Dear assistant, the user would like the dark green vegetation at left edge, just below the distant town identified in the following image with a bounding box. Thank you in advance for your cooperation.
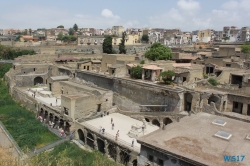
[0,45,36,60]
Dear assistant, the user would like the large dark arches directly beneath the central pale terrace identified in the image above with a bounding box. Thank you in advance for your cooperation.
[77,129,137,166]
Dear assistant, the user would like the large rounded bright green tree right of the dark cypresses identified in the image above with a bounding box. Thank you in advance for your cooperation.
[145,43,172,61]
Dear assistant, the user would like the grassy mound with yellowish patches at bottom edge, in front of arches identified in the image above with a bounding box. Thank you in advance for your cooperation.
[31,142,117,166]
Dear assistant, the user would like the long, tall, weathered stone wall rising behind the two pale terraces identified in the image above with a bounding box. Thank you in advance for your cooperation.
[76,71,183,112]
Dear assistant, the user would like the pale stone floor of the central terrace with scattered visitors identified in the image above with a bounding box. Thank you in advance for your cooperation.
[82,113,159,148]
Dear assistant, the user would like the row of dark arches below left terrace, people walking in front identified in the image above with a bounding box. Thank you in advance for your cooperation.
[39,108,70,133]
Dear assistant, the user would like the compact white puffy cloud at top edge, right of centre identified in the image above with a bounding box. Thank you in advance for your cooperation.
[177,0,201,11]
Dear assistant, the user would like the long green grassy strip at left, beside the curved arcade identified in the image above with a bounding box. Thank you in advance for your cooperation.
[0,81,58,151]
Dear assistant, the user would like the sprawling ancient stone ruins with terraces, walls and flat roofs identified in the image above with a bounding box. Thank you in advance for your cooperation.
[4,41,250,166]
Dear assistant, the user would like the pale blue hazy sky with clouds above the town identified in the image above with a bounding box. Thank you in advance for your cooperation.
[0,0,250,31]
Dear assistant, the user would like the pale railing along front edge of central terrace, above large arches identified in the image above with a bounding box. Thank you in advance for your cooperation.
[81,122,140,153]
